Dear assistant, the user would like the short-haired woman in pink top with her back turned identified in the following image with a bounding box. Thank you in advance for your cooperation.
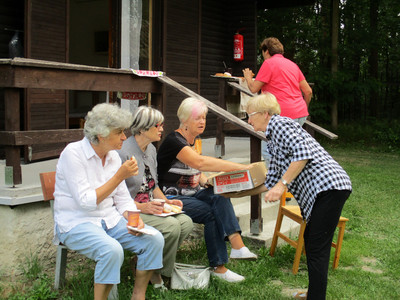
[243,37,312,166]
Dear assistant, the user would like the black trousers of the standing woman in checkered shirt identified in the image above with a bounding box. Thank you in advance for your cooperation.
[304,190,350,300]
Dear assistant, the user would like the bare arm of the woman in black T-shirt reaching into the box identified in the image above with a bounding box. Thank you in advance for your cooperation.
[176,146,250,172]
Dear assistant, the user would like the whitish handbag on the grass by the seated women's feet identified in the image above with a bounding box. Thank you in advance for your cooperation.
[171,263,210,290]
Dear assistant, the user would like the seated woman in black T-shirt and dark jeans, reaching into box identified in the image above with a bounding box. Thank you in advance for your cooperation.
[157,98,257,282]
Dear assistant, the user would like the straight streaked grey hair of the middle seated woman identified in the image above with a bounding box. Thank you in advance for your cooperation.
[131,105,164,135]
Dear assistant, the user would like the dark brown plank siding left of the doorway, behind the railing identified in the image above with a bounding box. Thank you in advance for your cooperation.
[24,0,69,162]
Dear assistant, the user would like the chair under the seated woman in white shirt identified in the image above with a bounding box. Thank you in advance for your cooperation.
[39,172,118,300]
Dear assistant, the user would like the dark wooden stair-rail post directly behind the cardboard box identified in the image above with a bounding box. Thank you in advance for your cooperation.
[250,135,263,234]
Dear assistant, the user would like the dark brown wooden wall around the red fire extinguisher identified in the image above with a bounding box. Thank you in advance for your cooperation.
[159,0,256,137]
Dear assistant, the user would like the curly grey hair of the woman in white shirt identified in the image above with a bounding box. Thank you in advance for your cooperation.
[83,103,132,145]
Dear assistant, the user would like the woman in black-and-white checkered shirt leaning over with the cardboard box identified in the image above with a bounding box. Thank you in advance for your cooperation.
[246,93,352,300]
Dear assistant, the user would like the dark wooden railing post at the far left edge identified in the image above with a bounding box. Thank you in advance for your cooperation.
[4,88,22,185]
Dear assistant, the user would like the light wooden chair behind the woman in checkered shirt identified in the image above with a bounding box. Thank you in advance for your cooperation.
[269,192,349,274]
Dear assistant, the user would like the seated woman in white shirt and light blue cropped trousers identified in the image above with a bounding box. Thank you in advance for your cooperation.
[54,103,164,299]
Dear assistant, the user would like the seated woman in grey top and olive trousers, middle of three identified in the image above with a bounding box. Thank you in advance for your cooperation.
[118,105,193,289]
